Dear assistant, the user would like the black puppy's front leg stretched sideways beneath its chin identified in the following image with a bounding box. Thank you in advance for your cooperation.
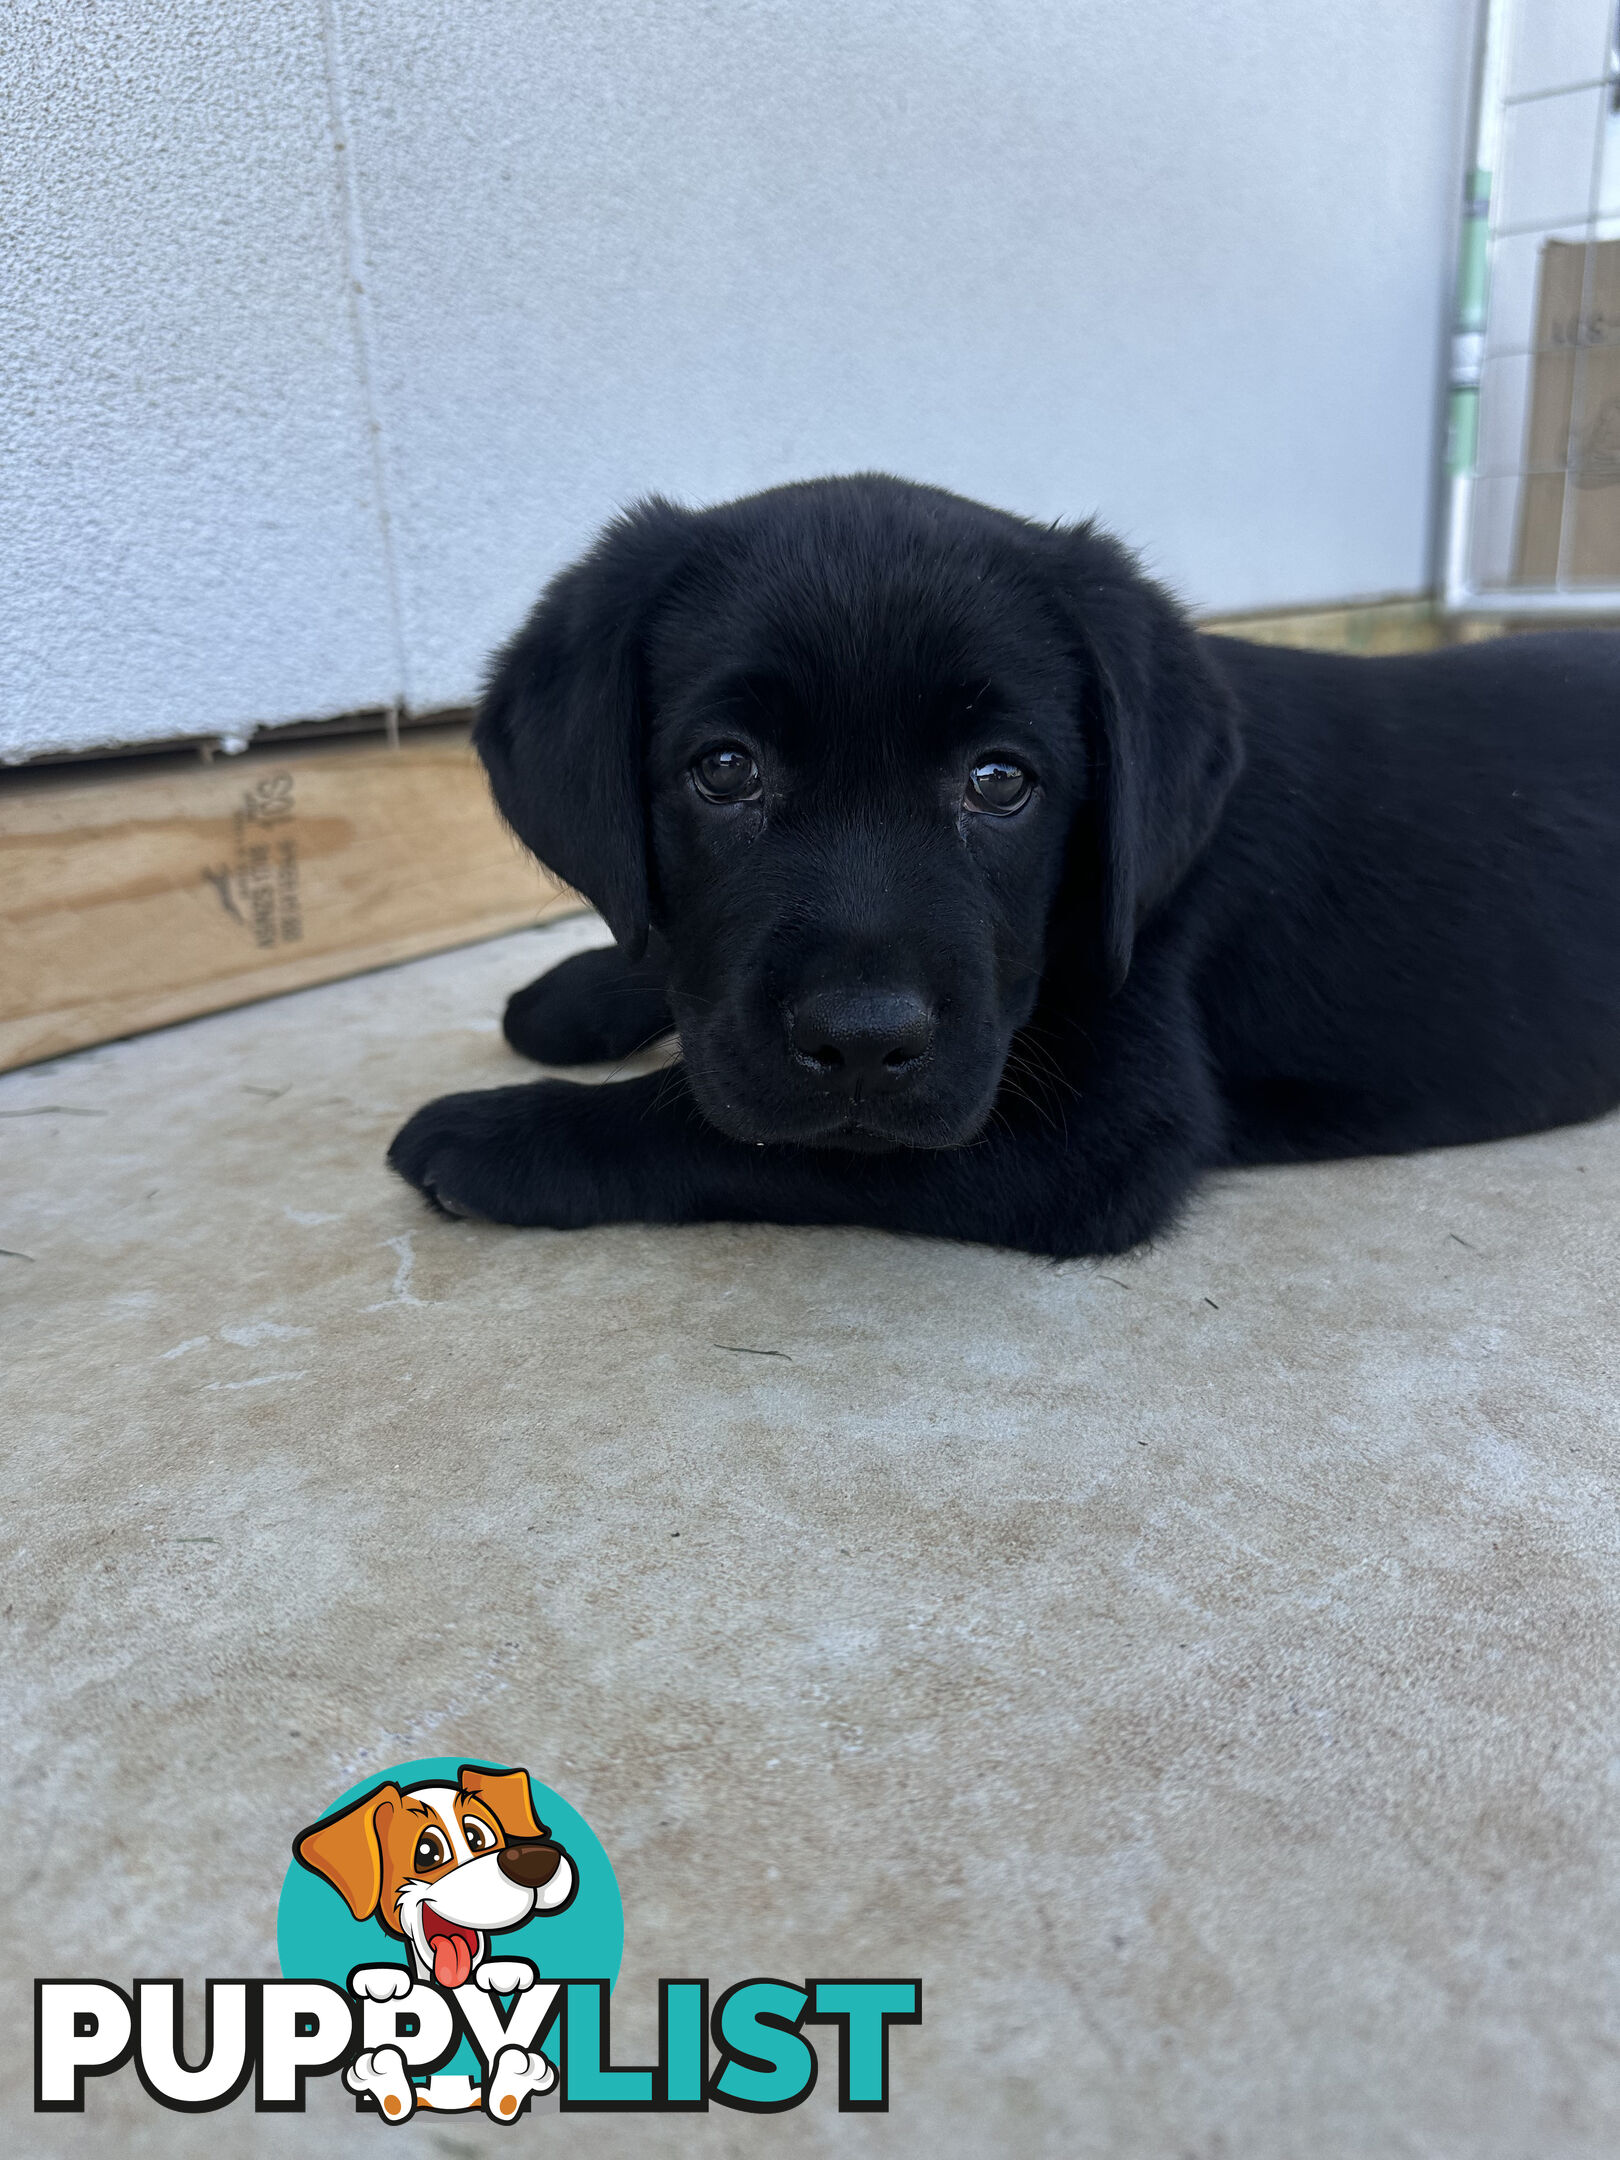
[389,1032,1210,1257]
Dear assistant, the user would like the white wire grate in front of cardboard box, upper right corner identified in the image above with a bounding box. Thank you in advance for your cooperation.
[1445,0,1620,616]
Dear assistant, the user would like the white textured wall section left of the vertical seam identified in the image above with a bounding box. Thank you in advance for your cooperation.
[0,0,395,756]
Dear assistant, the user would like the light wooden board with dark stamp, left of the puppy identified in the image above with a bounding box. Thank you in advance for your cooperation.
[0,726,583,1071]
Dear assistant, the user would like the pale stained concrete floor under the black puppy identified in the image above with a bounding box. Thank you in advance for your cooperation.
[0,920,1620,2160]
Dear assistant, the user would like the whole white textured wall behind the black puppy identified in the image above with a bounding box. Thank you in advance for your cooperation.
[0,0,1471,756]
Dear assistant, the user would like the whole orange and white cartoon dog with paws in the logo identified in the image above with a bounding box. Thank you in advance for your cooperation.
[292,1763,579,2121]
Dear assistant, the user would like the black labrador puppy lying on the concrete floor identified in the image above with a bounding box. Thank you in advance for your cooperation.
[389,475,1620,1255]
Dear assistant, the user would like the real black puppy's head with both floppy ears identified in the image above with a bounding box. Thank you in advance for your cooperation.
[477,475,1238,1149]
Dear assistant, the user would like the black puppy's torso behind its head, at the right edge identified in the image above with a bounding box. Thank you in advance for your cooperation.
[1186,631,1620,1162]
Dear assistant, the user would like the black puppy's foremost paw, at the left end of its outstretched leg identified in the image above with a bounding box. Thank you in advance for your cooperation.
[389,1080,605,1229]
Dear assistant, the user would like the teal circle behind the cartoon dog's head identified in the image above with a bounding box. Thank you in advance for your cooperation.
[276,1756,624,1987]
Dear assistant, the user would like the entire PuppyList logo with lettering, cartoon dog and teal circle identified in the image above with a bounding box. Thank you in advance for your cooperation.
[35,1756,922,2123]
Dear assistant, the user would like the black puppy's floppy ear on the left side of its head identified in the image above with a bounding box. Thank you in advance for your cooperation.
[473,497,693,959]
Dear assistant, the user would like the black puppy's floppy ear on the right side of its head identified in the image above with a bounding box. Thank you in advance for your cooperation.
[1052,525,1242,989]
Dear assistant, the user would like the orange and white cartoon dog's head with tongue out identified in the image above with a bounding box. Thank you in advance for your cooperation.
[292,1763,577,1987]
